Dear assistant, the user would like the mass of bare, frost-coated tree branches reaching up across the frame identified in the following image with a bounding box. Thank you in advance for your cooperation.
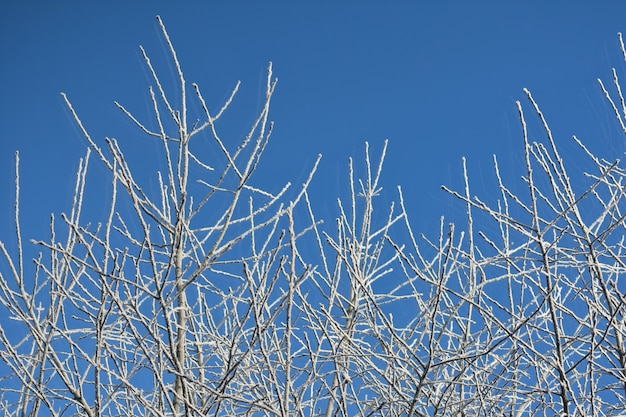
[0,18,626,417]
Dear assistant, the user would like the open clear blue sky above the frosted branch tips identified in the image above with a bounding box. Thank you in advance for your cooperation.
[0,0,626,245]
